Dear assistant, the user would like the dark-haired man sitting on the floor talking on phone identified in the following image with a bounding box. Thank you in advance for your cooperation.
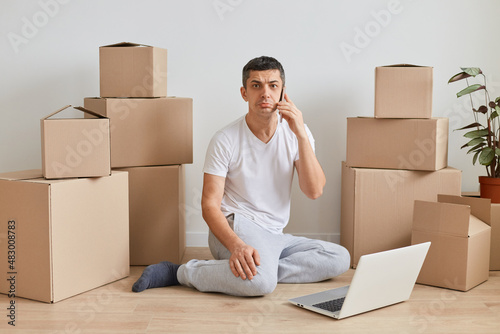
[132,56,350,296]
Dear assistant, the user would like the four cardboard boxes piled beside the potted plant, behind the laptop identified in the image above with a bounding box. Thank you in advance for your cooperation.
[341,65,491,291]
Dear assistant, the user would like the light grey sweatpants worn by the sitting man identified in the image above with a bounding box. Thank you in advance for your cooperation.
[177,214,350,296]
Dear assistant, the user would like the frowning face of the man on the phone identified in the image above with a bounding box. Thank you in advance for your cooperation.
[241,70,283,115]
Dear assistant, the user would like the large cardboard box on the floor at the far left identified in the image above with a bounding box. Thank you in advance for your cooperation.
[0,170,129,303]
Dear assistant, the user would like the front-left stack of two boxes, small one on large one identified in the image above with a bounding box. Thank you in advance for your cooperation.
[0,106,130,303]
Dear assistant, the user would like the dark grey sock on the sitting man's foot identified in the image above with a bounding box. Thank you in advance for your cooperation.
[132,261,180,292]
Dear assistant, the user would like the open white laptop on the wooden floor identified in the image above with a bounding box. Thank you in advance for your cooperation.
[289,242,431,319]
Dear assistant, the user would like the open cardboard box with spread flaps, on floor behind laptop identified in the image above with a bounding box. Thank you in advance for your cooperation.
[411,196,491,291]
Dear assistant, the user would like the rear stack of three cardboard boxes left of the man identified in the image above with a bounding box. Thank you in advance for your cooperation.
[84,43,193,265]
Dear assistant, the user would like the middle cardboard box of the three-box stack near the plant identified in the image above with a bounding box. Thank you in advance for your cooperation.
[346,117,448,171]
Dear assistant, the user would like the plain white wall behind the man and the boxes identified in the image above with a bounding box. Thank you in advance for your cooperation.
[0,0,500,245]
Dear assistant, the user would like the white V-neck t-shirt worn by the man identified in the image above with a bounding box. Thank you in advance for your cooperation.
[203,116,314,233]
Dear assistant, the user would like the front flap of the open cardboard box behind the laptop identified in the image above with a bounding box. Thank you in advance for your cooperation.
[412,200,471,238]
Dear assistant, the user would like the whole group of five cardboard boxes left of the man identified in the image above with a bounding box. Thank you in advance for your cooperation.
[0,43,193,302]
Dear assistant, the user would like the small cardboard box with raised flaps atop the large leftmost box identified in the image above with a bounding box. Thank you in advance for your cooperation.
[40,106,111,179]
